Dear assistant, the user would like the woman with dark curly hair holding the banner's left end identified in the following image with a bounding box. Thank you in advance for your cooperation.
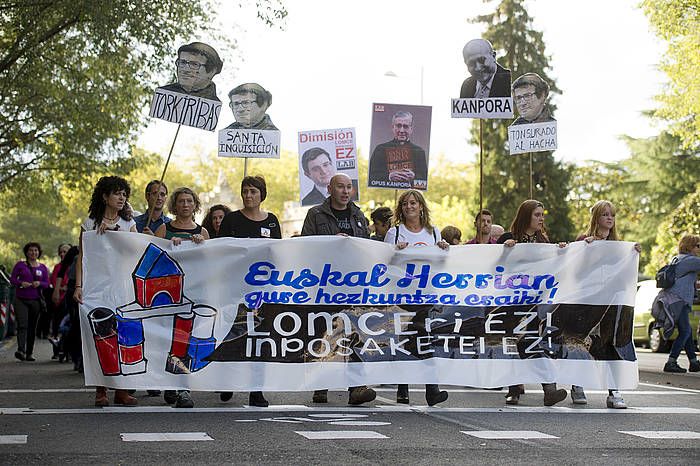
[73,176,138,406]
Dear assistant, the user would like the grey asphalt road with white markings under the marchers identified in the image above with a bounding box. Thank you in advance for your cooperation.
[0,340,700,465]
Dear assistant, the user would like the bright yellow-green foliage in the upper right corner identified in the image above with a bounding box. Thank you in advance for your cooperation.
[642,0,700,151]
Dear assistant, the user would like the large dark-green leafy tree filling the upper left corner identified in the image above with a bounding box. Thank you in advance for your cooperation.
[0,0,286,190]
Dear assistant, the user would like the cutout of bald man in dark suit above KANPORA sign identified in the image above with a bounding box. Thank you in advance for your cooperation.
[460,39,510,99]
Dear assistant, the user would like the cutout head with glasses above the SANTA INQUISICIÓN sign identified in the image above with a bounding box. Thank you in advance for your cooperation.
[228,83,277,129]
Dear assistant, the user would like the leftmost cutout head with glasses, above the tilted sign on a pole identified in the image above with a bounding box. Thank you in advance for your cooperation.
[158,42,223,102]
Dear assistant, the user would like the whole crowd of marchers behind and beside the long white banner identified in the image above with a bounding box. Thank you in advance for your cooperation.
[11,174,700,408]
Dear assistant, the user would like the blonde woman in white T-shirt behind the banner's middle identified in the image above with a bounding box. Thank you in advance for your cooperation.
[384,190,450,406]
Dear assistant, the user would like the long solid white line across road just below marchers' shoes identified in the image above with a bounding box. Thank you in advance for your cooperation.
[0,405,700,417]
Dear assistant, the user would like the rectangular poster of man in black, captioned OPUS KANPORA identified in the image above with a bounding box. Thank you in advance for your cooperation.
[367,103,432,191]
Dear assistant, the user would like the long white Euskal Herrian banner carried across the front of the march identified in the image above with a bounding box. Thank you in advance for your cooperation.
[81,232,638,391]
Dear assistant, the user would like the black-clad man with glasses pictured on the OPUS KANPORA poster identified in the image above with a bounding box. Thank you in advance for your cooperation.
[369,111,428,190]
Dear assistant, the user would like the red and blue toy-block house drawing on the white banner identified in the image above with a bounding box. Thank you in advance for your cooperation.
[88,243,217,375]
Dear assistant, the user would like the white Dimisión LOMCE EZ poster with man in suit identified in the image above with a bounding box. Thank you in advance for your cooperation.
[298,128,360,206]
